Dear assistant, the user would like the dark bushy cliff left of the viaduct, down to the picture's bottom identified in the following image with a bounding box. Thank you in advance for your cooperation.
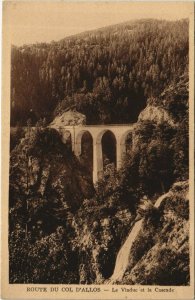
[9,128,94,283]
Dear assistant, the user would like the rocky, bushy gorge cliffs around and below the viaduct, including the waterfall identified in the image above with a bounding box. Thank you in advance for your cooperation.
[9,72,190,285]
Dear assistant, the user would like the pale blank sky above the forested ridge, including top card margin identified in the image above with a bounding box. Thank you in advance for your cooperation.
[3,1,192,46]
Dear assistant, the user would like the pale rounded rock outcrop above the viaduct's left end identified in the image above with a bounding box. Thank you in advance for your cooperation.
[50,110,86,129]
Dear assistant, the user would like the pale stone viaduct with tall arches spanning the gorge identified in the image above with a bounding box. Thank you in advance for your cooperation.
[56,124,134,183]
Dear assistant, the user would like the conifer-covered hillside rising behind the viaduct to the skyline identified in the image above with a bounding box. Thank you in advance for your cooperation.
[11,20,188,126]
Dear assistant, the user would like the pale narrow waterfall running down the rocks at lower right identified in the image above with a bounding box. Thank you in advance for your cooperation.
[107,192,170,284]
